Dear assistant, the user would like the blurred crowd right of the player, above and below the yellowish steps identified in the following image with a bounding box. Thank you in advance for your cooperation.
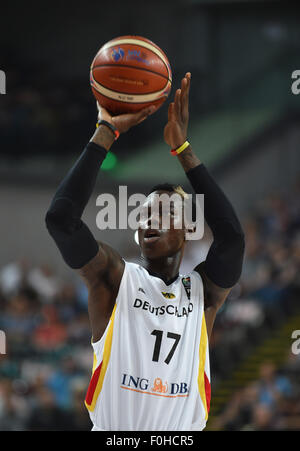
[211,178,300,431]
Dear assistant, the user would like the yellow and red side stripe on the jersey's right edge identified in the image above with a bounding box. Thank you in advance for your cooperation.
[198,312,211,420]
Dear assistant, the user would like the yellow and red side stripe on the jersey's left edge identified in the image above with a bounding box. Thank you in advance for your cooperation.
[85,304,116,412]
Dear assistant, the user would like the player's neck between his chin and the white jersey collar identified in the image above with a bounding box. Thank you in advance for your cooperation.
[142,254,181,285]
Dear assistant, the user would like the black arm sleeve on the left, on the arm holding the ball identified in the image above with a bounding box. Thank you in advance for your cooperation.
[46,142,107,269]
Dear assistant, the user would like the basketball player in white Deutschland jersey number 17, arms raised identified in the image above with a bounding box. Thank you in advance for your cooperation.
[46,73,244,431]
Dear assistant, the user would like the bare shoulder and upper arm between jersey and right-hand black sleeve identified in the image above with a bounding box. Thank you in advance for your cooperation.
[194,262,231,338]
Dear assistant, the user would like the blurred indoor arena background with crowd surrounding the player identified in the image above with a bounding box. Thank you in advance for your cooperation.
[0,0,300,431]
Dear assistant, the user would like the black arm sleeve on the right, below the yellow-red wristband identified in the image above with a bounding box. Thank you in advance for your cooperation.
[186,164,245,288]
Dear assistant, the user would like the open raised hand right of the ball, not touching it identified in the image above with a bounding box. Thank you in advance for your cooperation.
[164,72,191,149]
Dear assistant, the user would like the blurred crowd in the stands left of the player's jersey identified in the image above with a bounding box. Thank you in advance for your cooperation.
[0,260,93,431]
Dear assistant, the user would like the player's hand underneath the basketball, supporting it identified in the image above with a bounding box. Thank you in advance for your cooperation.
[97,102,157,134]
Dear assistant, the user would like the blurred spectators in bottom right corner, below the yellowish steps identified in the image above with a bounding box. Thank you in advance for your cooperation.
[213,358,300,431]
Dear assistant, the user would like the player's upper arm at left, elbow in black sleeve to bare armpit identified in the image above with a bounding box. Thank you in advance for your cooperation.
[46,192,125,340]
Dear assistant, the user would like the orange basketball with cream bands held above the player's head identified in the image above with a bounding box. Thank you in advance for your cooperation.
[90,36,172,114]
